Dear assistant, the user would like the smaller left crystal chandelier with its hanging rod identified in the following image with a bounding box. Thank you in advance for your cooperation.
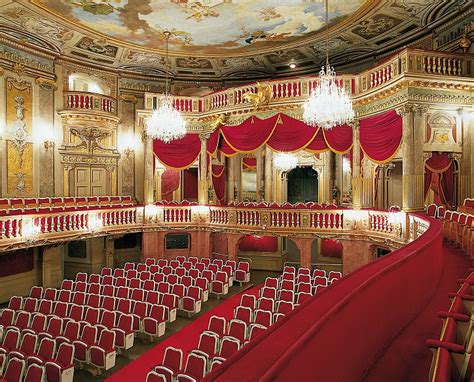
[145,31,186,143]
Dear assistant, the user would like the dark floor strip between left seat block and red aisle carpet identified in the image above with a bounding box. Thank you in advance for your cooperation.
[74,271,279,382]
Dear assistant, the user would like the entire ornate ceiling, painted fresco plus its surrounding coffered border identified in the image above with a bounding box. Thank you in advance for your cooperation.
[0,0,472,81]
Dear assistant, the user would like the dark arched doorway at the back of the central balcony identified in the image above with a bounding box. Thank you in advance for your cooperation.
[287,166,319,203]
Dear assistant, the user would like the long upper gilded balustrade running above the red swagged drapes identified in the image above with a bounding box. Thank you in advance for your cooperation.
[145,49,474,117]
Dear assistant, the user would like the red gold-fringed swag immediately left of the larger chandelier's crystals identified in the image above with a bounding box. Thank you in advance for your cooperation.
[267,114,318,152]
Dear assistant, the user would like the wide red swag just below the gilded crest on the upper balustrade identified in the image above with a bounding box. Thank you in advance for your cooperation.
[221,117,276,153]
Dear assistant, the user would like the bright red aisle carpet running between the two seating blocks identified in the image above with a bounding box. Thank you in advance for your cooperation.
[106,286,260,382]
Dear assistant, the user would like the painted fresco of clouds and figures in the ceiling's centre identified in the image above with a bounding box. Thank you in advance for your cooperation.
[33,0,364,54]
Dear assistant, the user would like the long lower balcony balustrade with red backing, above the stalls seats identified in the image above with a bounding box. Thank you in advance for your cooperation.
[0,205,429,250]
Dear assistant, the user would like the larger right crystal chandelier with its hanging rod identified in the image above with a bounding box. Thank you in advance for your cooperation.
[303,0,354,130]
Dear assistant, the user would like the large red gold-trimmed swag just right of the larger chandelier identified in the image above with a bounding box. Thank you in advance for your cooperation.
[359,110,403,163]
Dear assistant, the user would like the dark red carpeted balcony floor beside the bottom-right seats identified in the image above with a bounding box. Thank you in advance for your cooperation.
[365,244,471,382]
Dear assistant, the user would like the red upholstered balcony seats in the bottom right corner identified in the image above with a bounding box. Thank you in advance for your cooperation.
[426,272,474,382]
